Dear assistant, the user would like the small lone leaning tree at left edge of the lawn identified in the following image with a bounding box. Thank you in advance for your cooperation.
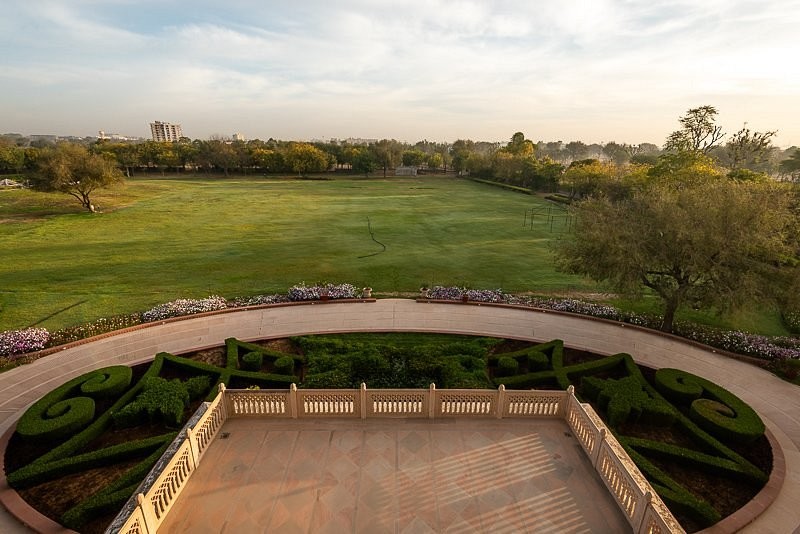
[33,143,124,213]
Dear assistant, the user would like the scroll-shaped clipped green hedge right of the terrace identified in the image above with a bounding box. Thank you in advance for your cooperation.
[655,368,764,443]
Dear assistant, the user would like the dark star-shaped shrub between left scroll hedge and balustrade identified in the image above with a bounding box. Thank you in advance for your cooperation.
[113,377,189,428]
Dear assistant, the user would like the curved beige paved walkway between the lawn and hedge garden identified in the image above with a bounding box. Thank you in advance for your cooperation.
[0,299,800,534]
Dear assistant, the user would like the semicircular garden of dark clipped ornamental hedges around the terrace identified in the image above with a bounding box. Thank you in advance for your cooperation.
[6,336,769,529]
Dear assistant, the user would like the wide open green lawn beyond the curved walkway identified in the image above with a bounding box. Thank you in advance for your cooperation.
[0,176,596,330]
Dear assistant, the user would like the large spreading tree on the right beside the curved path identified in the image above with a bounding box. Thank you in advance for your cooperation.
[556,179,797,332]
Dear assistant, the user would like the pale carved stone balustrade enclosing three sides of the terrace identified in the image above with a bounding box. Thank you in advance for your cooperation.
[104,384,684,534]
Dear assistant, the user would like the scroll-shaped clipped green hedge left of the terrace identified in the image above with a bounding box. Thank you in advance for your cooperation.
[17,365,132,442]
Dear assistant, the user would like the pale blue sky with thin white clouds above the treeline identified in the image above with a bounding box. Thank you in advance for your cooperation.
[0,0,800,147]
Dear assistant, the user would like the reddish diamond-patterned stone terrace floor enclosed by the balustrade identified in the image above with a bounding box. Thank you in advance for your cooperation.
[159,418,631,534]
